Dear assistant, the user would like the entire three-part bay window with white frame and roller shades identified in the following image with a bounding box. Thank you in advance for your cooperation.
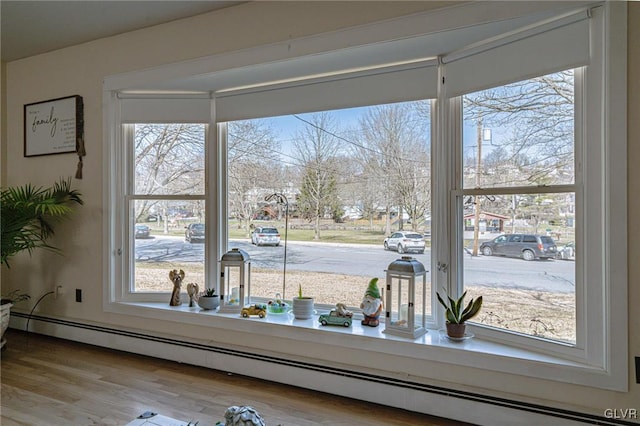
[106,0,626,387]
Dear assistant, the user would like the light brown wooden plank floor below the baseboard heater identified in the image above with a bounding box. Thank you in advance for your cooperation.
[0,330,470,426]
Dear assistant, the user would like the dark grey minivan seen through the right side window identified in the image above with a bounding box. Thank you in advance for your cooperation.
[480,234,558,260]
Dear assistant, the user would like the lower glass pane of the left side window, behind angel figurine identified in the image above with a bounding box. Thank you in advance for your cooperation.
[131,199,206,292]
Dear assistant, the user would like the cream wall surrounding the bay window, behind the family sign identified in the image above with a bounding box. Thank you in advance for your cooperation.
[0,2,640,422]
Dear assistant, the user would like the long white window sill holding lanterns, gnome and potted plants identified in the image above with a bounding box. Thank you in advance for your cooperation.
[107,302,620,390]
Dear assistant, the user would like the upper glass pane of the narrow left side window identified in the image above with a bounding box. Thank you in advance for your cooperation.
[134,124,205,195]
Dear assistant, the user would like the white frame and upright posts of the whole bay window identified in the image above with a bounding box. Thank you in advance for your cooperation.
[103,2,628,391]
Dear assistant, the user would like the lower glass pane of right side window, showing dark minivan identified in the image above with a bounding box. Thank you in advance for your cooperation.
[463,193,576,343]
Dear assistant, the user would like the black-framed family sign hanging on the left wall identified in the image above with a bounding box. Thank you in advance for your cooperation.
[24,95,84,157]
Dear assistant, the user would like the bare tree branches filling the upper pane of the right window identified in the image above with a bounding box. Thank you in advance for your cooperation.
[464,70,575,186]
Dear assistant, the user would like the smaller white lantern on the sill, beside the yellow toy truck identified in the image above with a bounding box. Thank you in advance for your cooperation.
[218,248,251,314]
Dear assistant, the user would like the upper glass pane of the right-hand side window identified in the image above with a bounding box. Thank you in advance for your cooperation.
[462,70,575,188]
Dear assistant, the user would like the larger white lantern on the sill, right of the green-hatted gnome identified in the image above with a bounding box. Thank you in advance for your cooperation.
[384,256,427,339]
